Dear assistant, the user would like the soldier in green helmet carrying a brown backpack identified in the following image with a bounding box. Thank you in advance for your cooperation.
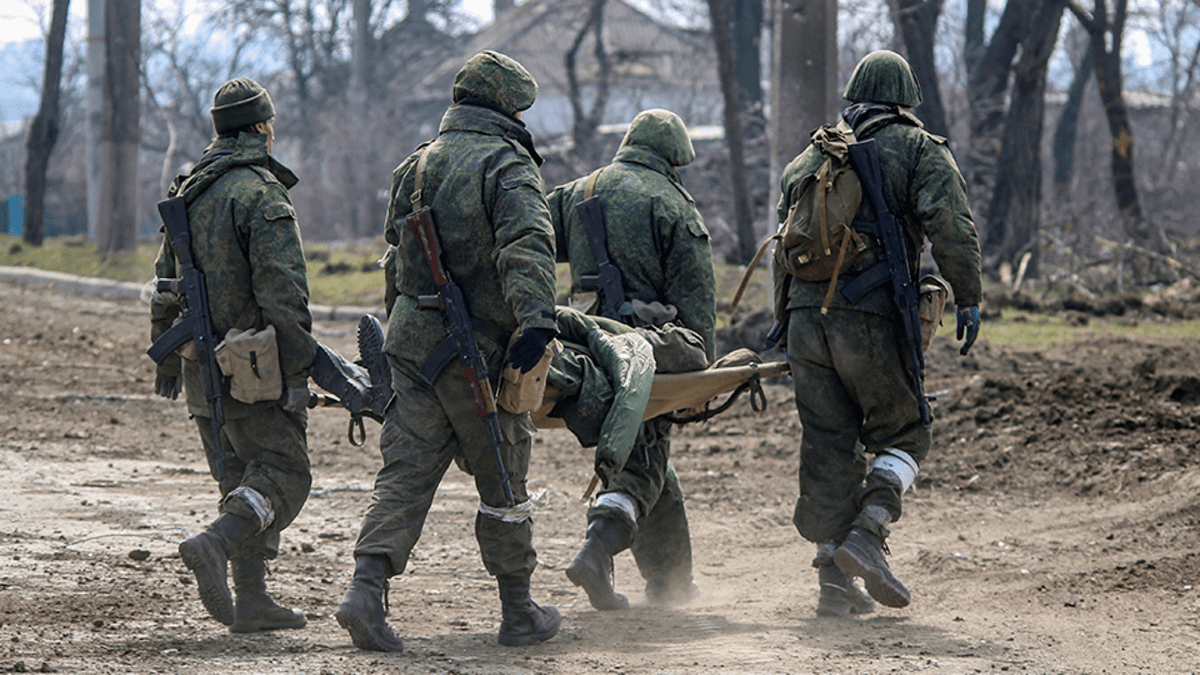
[775,50,980,615]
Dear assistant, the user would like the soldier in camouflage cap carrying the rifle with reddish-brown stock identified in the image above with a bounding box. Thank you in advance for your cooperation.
[337,52,560,651]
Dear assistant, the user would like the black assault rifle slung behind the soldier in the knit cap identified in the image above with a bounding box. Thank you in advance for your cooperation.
[146,197,226,482]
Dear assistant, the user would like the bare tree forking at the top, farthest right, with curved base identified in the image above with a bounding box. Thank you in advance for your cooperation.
[1068,0,1171,253]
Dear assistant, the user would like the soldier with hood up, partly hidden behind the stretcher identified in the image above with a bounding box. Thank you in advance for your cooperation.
[550,109,716,610]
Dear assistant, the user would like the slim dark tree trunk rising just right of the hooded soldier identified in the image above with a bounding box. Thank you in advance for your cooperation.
[707,0,756,263]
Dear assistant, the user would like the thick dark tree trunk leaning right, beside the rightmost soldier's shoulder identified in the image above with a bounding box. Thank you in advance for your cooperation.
[984,0,1066,276]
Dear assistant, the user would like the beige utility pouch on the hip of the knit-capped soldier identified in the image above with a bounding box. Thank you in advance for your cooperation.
[216,325,283,404]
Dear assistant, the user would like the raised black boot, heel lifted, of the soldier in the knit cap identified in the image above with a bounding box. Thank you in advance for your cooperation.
[179,513,258,626]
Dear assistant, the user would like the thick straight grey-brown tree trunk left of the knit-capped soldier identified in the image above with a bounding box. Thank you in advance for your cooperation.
[97,0,142,256]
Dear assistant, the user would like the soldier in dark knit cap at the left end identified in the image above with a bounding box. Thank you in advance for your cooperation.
[151,78,317,633]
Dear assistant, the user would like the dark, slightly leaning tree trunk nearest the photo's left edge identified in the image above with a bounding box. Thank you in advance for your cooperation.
[22,0,70,246]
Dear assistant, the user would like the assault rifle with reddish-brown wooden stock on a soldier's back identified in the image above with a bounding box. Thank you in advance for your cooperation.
[404,205,516,508]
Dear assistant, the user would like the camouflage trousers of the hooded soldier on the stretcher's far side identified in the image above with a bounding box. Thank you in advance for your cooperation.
[588,418,692,589]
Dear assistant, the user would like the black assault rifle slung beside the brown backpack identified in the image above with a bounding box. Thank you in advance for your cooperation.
[850,138,930,428]
